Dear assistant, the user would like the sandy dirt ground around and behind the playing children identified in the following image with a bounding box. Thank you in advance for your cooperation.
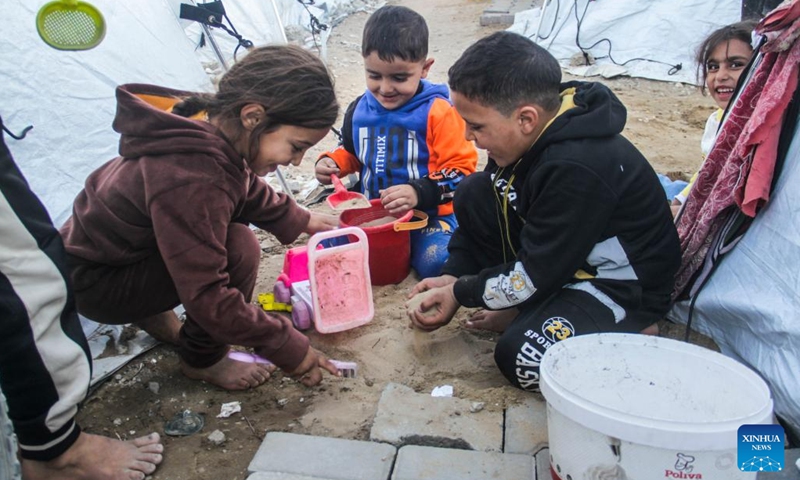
[79,0,714,480]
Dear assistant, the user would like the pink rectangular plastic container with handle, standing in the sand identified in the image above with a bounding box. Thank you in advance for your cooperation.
[308,227,375,333]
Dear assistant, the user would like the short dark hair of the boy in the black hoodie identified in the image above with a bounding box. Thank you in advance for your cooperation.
[447,32,561,116]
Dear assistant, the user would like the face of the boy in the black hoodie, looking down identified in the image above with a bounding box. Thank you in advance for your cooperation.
[450,92,531,167]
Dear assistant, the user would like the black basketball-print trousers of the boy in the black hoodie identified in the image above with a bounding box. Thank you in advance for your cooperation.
[444,172,649,391]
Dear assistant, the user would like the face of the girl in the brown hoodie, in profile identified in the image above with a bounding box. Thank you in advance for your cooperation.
[245,125,328,177]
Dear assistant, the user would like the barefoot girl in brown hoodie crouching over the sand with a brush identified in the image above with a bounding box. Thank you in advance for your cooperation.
[61,46,339,390]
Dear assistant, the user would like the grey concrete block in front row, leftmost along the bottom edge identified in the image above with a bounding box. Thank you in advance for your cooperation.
[248,432,397,480]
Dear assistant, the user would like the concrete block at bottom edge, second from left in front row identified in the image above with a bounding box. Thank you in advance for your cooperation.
[392,445,533,480]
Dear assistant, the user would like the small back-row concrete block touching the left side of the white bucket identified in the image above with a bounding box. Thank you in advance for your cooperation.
[503,395,547,455]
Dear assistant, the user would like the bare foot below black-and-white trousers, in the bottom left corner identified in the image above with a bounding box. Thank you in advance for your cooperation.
[22,432,164,480]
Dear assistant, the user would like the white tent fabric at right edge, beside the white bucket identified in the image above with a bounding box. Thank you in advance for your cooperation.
[669,116,800,436]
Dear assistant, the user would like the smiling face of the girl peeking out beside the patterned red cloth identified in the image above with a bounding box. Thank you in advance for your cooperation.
[704,39,753,109]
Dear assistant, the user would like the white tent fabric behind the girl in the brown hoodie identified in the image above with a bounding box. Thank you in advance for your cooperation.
[0,0,364,226]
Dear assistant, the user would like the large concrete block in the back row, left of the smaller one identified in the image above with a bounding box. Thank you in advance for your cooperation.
[370,383,503,452]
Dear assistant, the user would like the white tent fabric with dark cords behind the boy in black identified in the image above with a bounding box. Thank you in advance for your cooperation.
[509,0,741,84]
